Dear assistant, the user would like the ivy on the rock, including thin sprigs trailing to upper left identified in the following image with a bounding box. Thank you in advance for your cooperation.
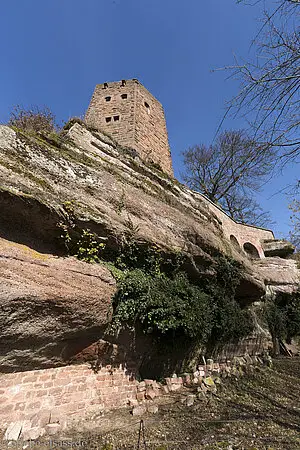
[60,211,253,345]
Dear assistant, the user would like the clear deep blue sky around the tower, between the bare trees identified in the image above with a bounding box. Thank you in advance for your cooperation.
[0,0,298,237]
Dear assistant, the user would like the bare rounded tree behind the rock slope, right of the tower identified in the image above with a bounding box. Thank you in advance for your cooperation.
[183,130,274,226]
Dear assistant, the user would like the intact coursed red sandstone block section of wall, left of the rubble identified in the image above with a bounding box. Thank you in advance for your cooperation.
[0,365,137,428]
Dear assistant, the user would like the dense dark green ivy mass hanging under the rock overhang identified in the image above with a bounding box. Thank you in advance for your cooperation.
[112,255,253,345]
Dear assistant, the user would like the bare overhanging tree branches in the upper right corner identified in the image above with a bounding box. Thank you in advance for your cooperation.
[229,0,300,161]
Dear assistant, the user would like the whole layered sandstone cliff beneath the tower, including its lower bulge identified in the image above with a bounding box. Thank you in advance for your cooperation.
[0,123,299,371]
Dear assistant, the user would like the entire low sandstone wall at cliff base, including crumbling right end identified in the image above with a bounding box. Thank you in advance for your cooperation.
[0,355,271,440]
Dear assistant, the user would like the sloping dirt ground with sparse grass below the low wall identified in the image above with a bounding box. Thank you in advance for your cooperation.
[0,358,300,450]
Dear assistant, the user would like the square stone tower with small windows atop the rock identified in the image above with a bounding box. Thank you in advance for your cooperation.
[85,79,173,176]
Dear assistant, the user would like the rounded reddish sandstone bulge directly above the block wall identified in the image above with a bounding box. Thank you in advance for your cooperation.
[0,238,116,372]
